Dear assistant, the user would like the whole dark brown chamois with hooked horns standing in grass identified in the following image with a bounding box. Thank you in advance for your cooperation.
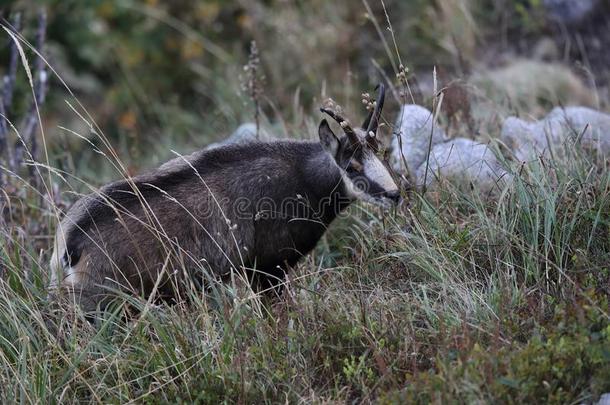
[50,85,400,311]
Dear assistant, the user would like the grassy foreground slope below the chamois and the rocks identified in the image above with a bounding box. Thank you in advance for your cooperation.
[0,145,610,403]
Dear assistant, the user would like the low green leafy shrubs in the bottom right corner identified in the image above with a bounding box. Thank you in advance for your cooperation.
[386,292,610,403]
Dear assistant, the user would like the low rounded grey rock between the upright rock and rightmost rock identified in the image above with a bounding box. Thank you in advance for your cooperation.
[416,138,510,190]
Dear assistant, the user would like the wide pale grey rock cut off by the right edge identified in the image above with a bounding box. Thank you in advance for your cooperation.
[500,107,610,161]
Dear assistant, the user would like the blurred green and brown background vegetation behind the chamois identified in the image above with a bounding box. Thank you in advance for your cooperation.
[0,0,609,179]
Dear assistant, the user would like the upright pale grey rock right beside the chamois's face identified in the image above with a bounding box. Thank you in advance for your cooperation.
[391,104,446,173]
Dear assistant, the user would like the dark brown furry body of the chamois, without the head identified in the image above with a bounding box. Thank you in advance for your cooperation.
[54,142,350,305]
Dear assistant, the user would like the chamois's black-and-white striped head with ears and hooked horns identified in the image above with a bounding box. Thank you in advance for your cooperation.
[318,84,400,206]
